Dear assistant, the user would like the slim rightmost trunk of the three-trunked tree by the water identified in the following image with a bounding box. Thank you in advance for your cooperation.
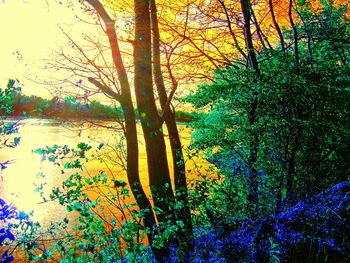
[150,0,192,239]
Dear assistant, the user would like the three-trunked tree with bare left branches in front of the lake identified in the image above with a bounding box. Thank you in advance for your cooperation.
[41,0,192,260]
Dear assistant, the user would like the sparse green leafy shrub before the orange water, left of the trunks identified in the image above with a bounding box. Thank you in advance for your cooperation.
[28,142,189,262]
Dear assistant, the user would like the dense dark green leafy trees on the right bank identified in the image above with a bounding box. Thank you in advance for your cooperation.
[187,0,350,221]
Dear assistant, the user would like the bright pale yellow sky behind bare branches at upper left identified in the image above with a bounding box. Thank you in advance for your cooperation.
[0,0,194,103]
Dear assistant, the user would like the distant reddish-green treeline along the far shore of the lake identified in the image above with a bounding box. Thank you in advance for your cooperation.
[0,92,191,122]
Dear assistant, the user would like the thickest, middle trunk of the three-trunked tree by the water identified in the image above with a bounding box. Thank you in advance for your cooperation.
[134,0,175,256]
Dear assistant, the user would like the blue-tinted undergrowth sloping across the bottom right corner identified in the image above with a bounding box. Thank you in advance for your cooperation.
[191,183,350,262]
